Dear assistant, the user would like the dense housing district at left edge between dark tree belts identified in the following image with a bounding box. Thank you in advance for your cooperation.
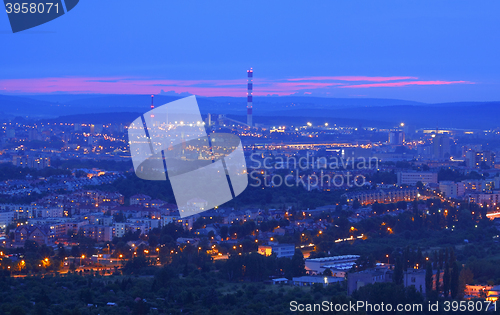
[0,190,184,246]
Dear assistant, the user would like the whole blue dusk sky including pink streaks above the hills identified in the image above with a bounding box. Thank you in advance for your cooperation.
[0,0,500,102]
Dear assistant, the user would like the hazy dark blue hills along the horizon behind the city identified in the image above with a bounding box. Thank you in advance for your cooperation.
[0,94,500,129]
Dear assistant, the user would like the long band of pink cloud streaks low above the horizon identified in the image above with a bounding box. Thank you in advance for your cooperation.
[0,76,474,97]
